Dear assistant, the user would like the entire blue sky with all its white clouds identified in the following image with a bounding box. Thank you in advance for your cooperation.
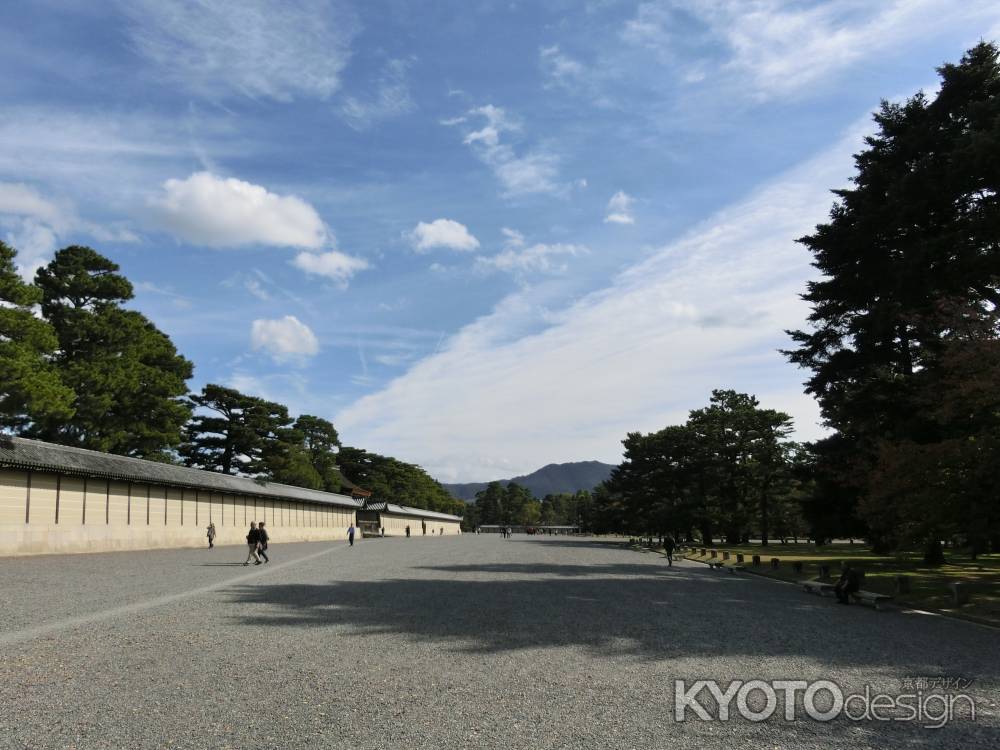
[0,0,1000,481]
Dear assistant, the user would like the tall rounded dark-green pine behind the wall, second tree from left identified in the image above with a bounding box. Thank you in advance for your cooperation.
[27,245,192,458]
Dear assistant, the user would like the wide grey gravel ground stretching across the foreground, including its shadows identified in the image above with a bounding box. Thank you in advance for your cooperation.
[0,535,1000,750]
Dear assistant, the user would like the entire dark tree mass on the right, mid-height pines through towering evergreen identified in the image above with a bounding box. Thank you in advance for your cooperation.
[595,43,1000,563]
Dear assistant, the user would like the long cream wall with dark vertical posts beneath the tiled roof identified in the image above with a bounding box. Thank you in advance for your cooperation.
[0,469,360,555]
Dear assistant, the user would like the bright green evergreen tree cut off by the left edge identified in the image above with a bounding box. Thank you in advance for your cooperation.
[0,242,73,429]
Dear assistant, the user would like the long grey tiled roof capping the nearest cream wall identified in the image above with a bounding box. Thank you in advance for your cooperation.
[0,436,362,508]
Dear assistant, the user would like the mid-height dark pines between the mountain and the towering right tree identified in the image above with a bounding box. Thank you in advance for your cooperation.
[594,391,808,544]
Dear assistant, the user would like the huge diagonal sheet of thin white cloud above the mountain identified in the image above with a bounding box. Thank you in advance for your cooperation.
[336,123,867,480]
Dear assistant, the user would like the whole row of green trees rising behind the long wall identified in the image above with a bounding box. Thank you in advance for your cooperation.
[0,242,464,514]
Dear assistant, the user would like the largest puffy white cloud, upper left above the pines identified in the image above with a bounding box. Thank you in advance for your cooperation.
[149,172,332,249]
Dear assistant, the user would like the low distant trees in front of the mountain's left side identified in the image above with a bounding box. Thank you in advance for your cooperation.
[466,482,594,529]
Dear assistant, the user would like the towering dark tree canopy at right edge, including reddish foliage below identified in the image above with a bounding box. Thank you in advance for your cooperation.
[787,43,1000,558]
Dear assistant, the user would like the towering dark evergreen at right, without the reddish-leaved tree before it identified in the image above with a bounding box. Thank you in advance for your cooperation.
[788,43,1000,559]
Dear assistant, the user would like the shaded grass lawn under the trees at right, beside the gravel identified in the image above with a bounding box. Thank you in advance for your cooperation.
[672,543,1000,625]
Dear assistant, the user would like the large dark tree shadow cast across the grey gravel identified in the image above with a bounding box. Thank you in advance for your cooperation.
[219,564,1000,680]
